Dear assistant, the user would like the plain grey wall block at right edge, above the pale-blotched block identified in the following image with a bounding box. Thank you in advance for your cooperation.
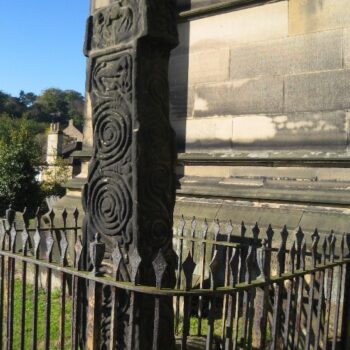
[285,70,350,112]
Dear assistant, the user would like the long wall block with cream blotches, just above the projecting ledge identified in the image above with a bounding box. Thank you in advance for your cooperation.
[232,111,347,149]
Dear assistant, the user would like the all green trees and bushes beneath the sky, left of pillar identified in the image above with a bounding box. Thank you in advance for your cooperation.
[0,88,84,215]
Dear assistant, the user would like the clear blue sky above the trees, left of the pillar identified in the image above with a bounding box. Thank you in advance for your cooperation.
[0,0,90,96]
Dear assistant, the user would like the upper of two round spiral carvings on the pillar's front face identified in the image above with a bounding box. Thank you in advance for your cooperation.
[94,102,132,164]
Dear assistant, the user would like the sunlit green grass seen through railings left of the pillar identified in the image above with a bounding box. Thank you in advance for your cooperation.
[13,280,71,349]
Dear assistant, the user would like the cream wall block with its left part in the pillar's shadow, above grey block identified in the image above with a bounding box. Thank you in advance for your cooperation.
[169,49,230,86]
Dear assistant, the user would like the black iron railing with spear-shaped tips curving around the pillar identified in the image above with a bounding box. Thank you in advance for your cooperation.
[0,206,350,350]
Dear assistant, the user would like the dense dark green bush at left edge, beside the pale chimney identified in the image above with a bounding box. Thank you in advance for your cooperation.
[0,119,42,214]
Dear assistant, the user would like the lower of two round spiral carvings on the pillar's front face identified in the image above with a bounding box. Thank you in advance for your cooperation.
[89,172,132,236]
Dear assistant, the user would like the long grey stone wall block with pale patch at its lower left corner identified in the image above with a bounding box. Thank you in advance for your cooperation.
[194,77,283,117]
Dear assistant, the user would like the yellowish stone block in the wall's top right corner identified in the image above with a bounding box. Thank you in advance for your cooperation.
[289,0,350,34]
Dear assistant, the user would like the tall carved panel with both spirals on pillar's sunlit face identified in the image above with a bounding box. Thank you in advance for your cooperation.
[85,51,133,244]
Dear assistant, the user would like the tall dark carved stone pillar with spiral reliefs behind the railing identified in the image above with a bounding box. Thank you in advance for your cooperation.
[83,0,177,349]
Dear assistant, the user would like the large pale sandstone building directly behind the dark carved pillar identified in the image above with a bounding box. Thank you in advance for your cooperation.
[60,0,350,238]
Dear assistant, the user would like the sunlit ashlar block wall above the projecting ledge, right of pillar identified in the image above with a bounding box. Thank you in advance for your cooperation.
[170,0,350,153]
